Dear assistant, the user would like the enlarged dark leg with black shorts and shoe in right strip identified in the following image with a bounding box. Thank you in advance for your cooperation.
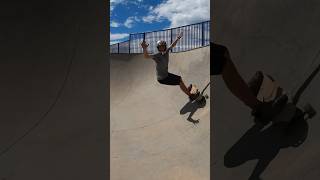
[210,42,281,124]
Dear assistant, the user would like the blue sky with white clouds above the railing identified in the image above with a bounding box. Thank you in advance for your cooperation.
[110,0,210,44]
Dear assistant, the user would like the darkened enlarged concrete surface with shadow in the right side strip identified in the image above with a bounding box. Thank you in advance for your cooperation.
[211,0,320,180]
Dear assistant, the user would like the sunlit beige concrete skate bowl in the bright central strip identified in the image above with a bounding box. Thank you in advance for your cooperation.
[110,47,210,180]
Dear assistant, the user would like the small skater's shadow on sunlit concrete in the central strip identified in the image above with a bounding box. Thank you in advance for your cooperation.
[180,98,207,124]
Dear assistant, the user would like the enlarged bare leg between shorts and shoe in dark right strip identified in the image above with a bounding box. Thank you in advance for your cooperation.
[222,58,261,109]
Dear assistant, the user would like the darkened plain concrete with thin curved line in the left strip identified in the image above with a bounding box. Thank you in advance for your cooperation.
[0,0,108,180]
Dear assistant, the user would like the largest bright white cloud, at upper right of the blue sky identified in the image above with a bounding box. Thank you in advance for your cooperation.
[143,0,210,27]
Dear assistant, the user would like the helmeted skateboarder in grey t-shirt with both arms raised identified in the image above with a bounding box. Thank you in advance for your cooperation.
[141,32,198,100]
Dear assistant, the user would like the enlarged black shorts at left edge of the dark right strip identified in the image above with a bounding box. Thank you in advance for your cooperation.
[210,42,229,75]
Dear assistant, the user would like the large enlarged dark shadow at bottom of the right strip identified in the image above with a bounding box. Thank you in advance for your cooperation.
[224,113,309,180]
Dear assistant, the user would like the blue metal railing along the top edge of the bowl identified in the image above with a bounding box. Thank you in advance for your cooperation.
[110,21,210,54]
